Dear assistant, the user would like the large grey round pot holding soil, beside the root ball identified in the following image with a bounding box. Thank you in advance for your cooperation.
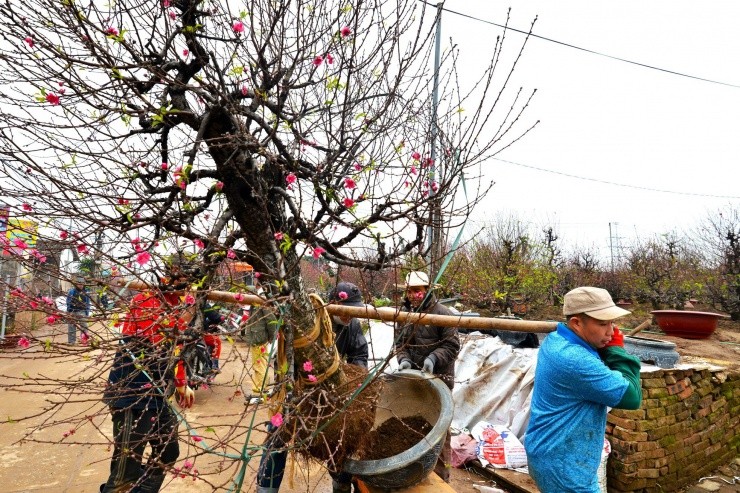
[344,370,453,489]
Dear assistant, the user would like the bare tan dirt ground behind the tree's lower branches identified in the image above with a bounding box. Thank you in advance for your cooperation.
[0,326,491,493]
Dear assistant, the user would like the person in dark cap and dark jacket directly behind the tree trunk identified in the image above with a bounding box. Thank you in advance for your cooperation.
[257,282,368,493]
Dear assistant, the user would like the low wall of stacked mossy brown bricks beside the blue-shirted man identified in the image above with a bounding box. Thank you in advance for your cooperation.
[606,366,740,492]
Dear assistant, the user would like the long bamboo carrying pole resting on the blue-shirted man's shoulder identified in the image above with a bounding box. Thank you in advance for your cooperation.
[115,281,558,333]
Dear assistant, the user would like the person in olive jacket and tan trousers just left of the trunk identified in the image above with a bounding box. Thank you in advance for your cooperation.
[246,286,277,404]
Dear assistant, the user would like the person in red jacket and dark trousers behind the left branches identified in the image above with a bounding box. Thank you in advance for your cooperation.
[100,276,195,493]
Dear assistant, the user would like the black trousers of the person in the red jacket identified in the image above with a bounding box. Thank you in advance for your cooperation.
[100,406,180,493]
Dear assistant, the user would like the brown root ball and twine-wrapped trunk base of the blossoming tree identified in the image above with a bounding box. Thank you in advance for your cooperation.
[281,294,382,471]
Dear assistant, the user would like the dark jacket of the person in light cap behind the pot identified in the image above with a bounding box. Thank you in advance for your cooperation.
[393,295,460,389]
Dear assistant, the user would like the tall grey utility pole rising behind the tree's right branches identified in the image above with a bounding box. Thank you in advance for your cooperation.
[427,2,444,278]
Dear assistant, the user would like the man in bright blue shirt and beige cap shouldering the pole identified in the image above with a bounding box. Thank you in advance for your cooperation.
[524,287,642,493]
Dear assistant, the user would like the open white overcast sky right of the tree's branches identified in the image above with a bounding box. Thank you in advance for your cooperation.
[434,0,740,256]
